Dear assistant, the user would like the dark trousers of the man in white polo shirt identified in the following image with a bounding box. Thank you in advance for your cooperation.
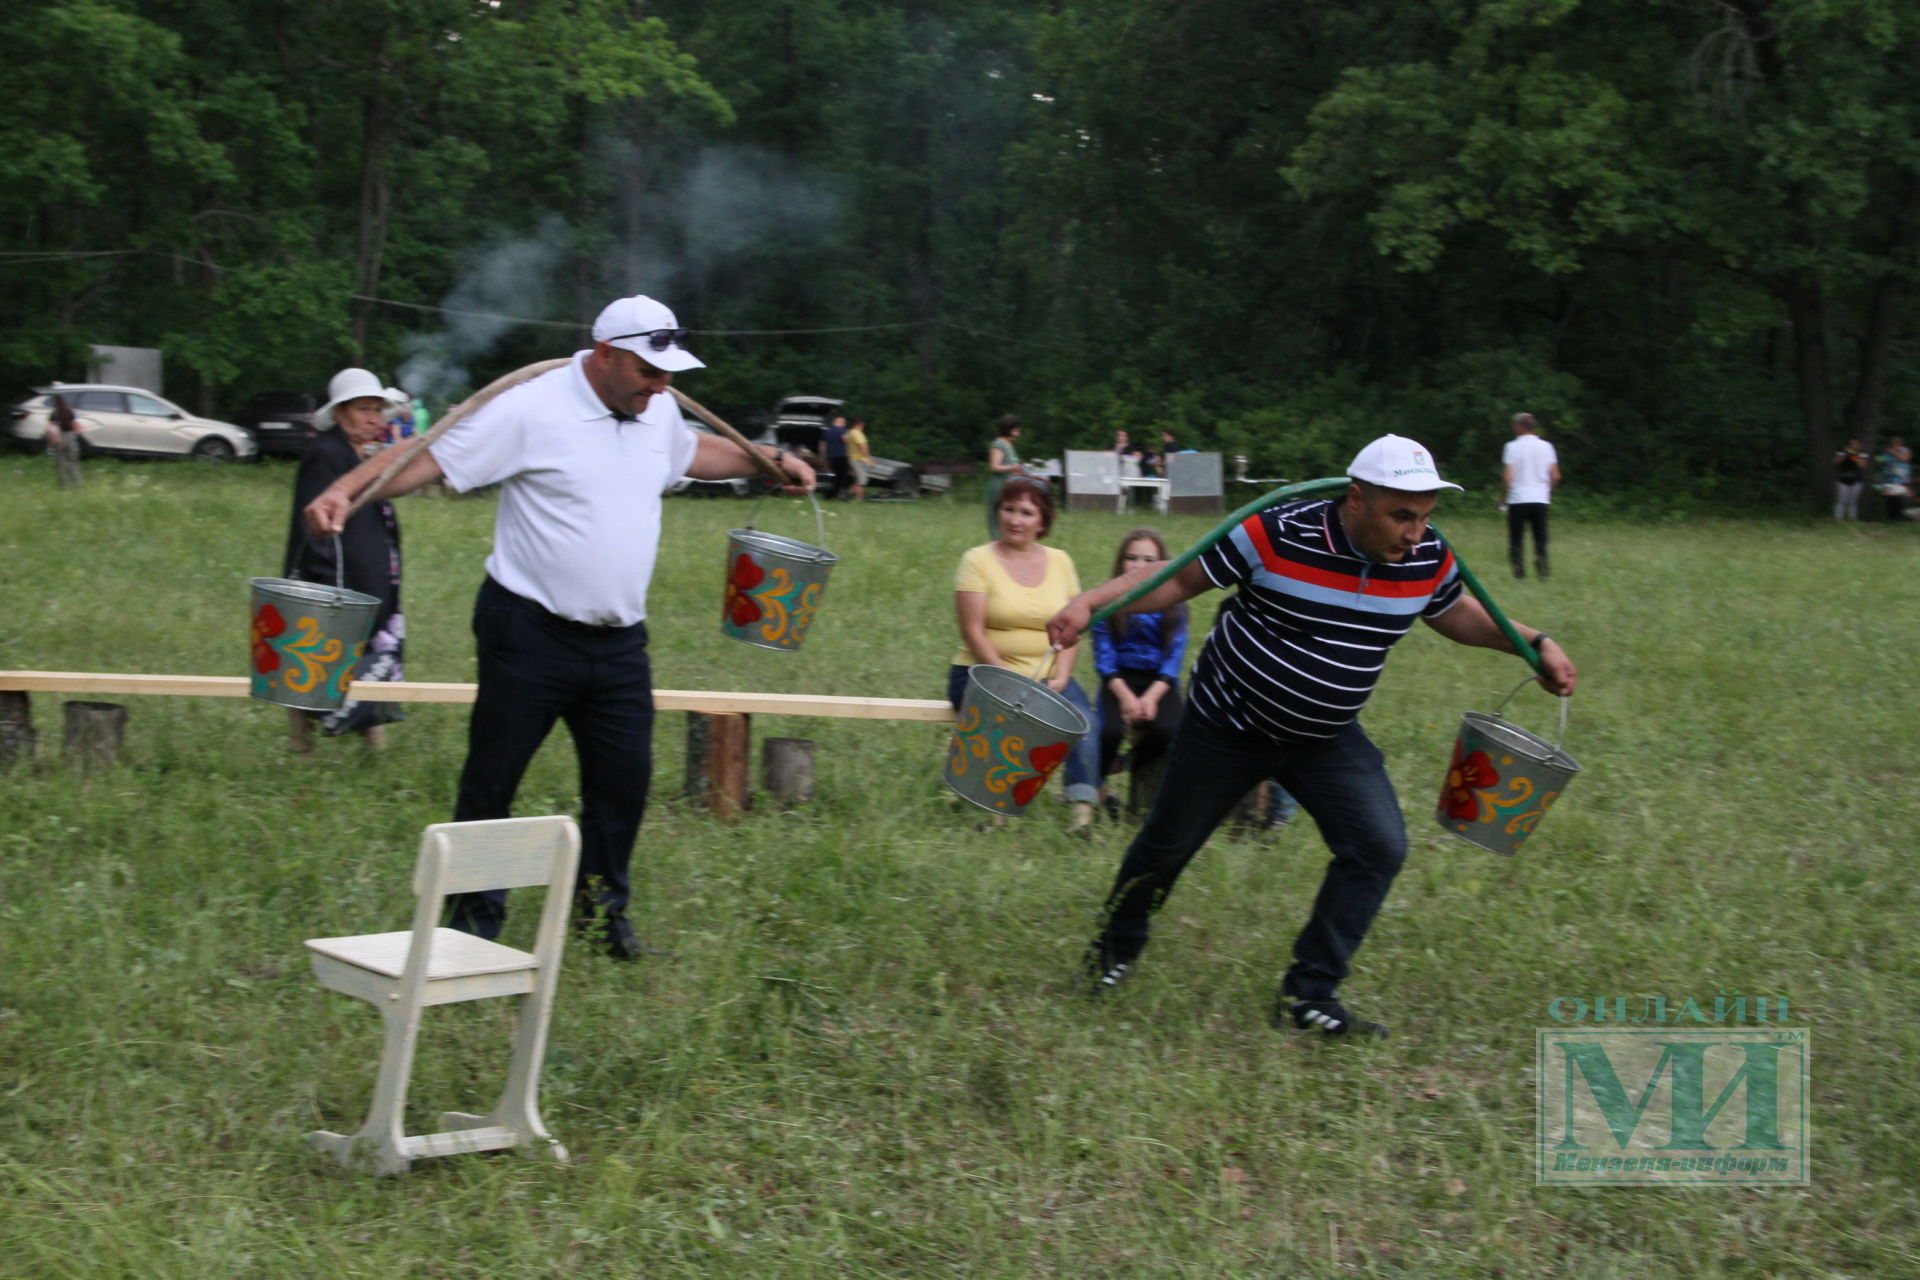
[449,578,653,938]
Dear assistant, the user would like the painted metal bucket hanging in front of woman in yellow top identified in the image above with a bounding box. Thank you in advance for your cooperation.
[945,666,1092,814]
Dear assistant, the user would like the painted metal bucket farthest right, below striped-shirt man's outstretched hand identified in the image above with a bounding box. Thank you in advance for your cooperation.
[1434,676,1580,856]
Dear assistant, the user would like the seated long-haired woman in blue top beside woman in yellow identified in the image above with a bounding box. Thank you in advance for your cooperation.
[1092,530,1187,812]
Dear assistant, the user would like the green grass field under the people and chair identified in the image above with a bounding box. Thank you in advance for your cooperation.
[0,459,1920,1280]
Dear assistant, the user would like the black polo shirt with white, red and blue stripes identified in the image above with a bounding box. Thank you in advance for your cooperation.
[1188,499,1461,743]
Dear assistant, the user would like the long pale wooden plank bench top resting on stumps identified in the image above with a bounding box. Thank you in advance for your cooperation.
[0,672,954,723]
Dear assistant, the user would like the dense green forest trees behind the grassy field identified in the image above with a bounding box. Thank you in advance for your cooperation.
[0,0,1920,503]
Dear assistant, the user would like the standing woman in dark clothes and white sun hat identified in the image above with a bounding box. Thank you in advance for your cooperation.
[284,368,407,756]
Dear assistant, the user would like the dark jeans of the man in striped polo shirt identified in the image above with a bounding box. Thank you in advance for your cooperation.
[1096,714,1407,1000]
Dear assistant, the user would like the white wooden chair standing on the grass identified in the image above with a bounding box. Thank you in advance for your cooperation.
[307,818,580,1174]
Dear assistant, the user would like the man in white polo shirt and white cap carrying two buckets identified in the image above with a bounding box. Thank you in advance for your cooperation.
[307,296,814,960]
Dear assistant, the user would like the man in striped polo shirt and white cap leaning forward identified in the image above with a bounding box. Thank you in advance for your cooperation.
[1048,436,1574,1036]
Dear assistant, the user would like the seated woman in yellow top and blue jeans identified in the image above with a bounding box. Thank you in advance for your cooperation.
[947,476,1100,829]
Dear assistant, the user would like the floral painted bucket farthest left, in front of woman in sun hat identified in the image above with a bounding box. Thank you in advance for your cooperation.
[248,578,380,712]
